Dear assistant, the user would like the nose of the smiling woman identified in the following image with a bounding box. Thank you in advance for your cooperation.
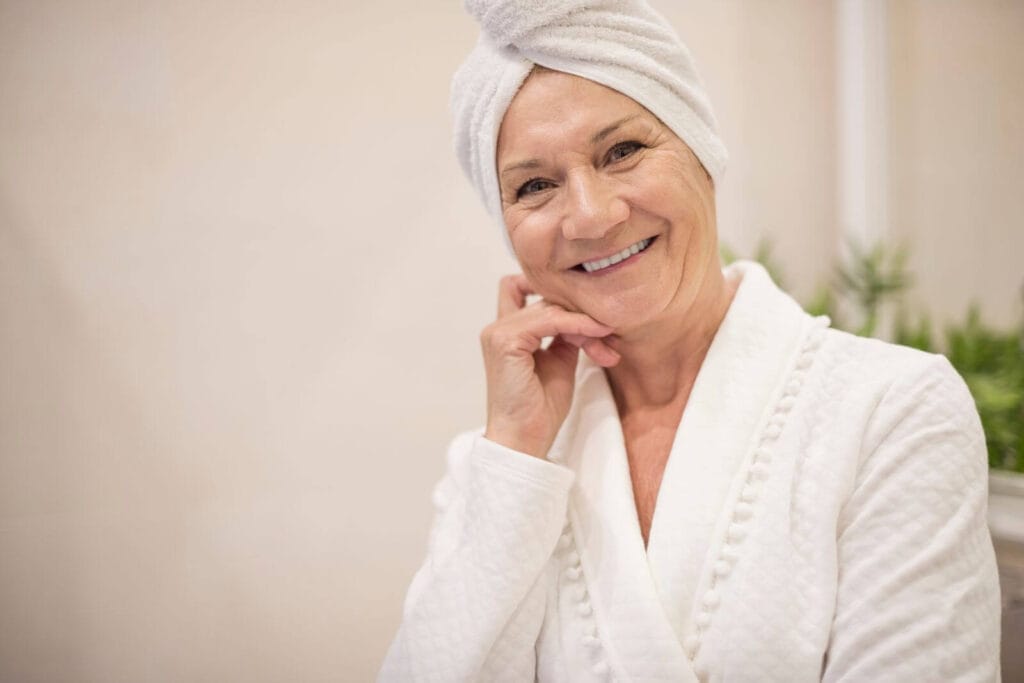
[562,168,630,240]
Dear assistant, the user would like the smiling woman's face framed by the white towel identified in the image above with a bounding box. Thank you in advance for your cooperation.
[497,70,718,332]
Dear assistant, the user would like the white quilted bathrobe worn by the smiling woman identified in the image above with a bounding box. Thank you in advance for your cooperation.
[380,262,999,683]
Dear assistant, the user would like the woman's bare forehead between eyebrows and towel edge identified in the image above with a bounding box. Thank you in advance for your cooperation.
[498,70,651,160]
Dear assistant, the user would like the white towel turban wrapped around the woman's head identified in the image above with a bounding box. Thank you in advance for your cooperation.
[452,0,727,250]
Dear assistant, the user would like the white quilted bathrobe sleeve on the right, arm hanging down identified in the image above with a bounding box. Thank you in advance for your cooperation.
[822,355,999,682]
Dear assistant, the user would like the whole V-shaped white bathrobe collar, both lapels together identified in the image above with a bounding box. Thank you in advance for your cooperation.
[552,262,811,681]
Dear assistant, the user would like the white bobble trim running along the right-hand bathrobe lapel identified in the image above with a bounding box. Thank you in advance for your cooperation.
[683,315,829,661]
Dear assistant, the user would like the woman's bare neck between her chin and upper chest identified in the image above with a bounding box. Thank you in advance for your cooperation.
[605,259,738,416]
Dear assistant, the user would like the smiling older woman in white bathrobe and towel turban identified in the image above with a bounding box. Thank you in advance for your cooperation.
[381,0,999,682]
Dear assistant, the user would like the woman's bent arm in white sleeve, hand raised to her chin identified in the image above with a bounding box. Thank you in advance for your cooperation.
[380,274,618,681]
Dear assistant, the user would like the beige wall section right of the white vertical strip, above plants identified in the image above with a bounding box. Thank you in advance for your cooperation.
[890,0,1024,325]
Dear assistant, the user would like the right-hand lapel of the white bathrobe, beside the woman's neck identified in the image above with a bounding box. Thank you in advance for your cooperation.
[648,262,814,642]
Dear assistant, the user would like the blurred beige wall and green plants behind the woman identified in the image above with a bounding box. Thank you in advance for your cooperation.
[0,0,1024,682]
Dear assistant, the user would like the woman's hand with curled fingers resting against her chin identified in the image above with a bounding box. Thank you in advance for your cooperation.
[480,274,620,458]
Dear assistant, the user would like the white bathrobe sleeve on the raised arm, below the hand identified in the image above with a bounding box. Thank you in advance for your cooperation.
[378,433,574,682]
